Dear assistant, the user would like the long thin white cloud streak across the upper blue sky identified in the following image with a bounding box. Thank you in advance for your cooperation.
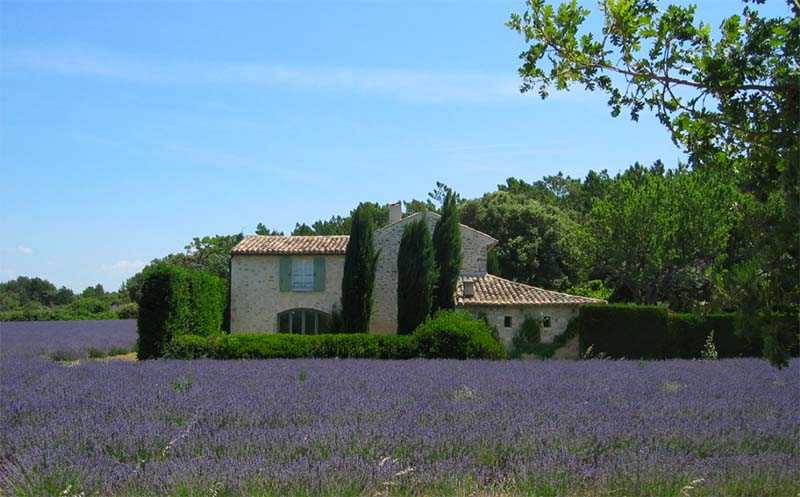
[4,47,520,102]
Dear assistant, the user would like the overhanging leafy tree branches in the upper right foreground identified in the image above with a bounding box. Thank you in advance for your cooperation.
[508,0,800,363]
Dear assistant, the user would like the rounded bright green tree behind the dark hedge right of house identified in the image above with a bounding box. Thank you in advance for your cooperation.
[586,168,745,310]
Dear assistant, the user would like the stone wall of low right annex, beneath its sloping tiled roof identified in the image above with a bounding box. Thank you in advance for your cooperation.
[464,305,579,347]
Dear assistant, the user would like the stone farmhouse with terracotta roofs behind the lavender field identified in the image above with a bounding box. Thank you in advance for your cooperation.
[231,203,598,344]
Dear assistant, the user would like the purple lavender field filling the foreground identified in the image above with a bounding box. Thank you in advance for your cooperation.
[0,322,800,497]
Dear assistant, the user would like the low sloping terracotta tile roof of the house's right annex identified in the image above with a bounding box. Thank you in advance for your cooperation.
[456,274,603,305]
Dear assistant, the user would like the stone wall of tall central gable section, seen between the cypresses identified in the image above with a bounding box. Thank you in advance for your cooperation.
[370,212,496,334]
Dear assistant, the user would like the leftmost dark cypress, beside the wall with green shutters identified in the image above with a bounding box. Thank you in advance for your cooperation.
[337,205,378,333]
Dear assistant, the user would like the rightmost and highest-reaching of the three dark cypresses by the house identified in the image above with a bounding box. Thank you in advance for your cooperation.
[433,189,461,310]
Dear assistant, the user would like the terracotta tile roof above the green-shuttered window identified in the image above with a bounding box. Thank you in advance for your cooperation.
[231,235,350,255]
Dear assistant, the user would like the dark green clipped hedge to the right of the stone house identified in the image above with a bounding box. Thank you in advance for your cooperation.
[577,304,798,359]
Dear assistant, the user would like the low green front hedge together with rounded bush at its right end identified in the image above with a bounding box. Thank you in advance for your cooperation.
[165,311,505,359]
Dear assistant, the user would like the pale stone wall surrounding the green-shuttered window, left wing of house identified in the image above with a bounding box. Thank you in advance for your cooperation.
[231,255,344,333]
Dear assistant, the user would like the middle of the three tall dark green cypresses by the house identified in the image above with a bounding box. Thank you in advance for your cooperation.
[397,214,436,335]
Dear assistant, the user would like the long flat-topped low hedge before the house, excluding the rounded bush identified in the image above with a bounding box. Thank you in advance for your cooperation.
[165,333,419,359]
